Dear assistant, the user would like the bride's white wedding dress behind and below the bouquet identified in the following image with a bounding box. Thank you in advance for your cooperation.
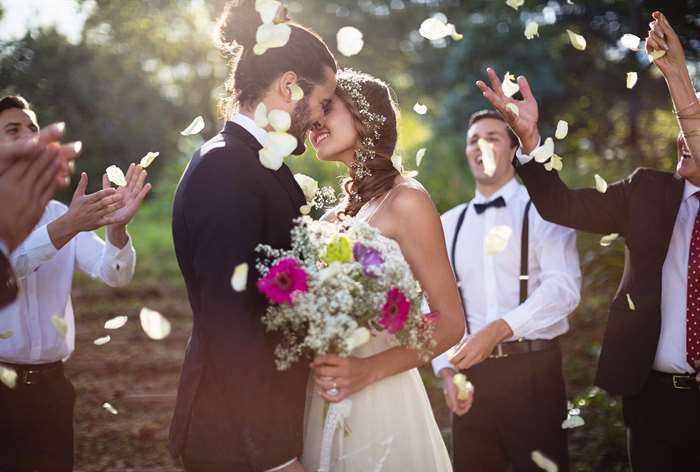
[302,180,452,472]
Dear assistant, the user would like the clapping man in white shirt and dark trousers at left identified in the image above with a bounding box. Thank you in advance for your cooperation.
[0,97,150,472]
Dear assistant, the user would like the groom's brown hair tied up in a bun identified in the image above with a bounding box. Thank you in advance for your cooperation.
[217,0,338,118]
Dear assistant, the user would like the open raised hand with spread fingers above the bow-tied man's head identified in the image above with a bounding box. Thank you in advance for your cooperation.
[476,67,540,154]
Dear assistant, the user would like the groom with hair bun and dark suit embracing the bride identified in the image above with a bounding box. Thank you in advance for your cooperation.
[170,1,337,472]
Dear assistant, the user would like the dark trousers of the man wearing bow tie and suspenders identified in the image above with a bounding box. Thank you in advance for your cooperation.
[452,344,569,472]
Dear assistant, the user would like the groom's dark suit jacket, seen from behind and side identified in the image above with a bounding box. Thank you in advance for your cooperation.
[170,122,308,471]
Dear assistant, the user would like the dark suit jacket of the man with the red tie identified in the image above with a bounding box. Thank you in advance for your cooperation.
[513,158,684,395]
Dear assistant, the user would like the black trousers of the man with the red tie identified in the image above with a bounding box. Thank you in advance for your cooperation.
[622,377,700,472]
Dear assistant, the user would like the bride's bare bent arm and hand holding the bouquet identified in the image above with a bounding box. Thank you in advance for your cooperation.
[311,188,464,402]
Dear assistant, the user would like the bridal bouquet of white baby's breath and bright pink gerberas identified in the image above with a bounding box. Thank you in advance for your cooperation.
[257,216,434,370]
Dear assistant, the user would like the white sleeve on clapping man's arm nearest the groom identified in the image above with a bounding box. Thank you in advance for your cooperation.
[75,231,136,287]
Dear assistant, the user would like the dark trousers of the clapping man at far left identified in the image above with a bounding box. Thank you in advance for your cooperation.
[0,366,75,472]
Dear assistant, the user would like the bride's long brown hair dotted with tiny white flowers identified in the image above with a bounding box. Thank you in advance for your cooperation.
[336,69,399,216]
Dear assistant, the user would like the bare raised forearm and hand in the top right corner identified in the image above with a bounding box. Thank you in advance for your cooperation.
[646,11,700,170]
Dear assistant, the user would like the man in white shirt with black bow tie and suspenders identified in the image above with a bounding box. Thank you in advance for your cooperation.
[433,110,581,472]
